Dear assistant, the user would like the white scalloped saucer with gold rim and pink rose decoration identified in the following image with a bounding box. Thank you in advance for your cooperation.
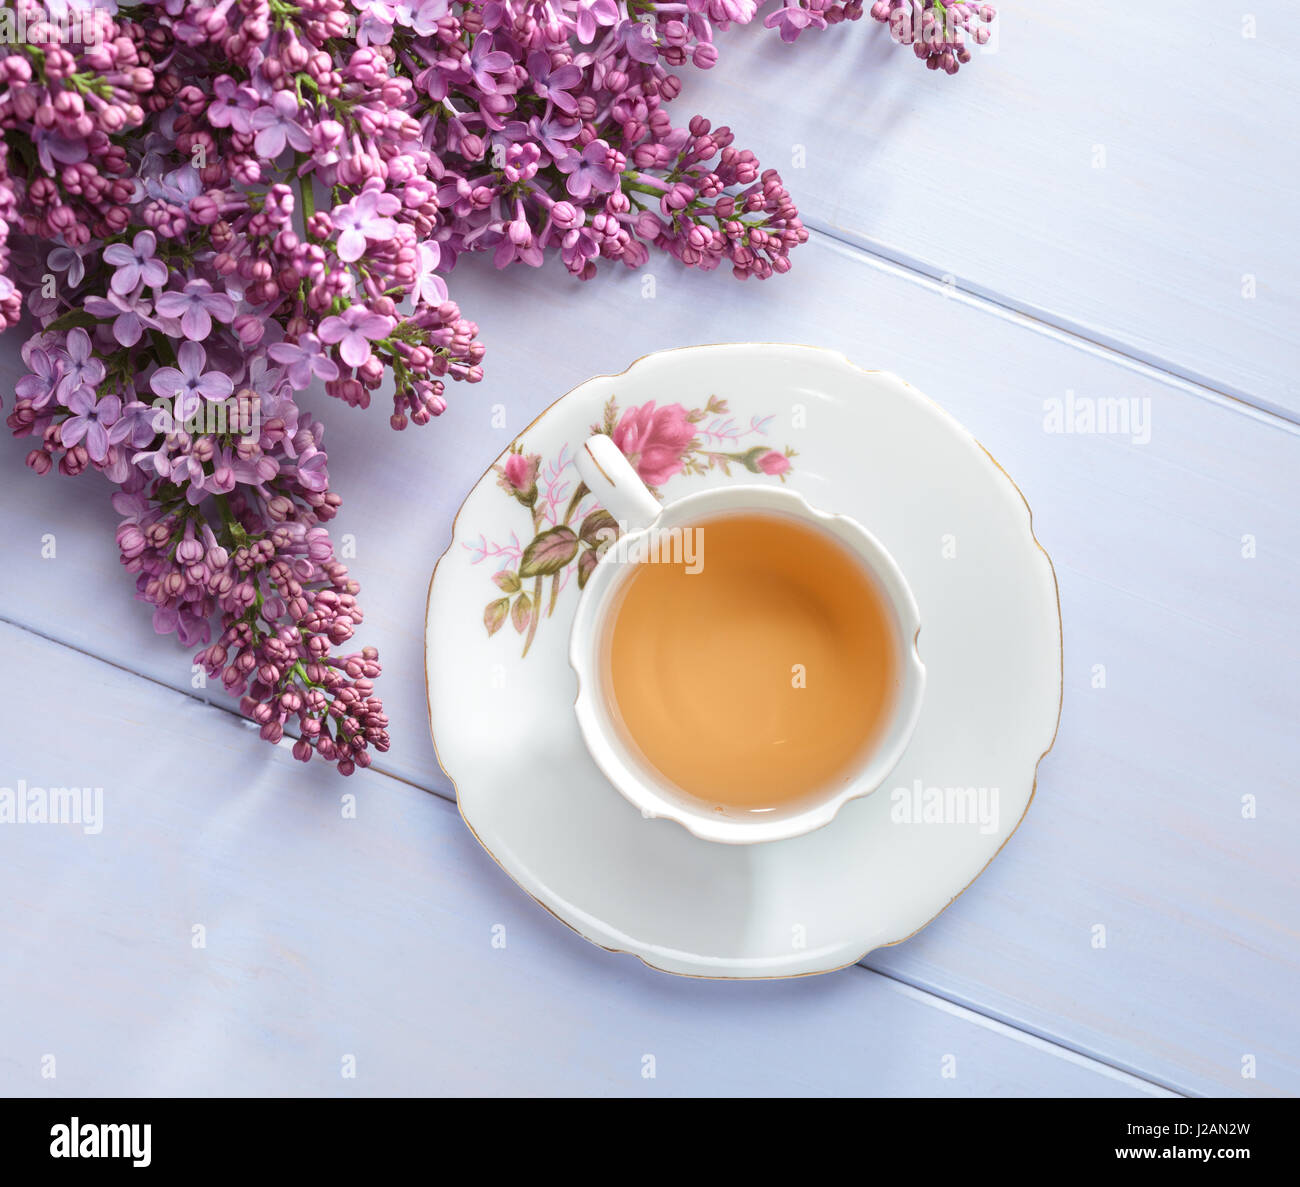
[425,345,1062,978]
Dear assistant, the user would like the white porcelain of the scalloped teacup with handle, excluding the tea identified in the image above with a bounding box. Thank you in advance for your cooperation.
[569,433,926,845]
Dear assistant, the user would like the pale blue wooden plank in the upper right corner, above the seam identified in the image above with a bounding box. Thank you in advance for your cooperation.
[679,0,1300,419]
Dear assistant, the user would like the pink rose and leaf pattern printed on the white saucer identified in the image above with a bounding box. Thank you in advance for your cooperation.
[464,397,796,655]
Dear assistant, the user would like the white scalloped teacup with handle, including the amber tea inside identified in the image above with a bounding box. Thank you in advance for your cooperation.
[569,434,926,844]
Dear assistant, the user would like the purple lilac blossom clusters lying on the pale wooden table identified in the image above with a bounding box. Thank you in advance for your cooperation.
[0,0,992,774]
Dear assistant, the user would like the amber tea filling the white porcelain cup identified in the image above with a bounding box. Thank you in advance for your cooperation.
[605,512,900,813]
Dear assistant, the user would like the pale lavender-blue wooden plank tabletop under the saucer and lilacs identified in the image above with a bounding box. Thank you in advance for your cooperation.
[0,9,1300,1096]
